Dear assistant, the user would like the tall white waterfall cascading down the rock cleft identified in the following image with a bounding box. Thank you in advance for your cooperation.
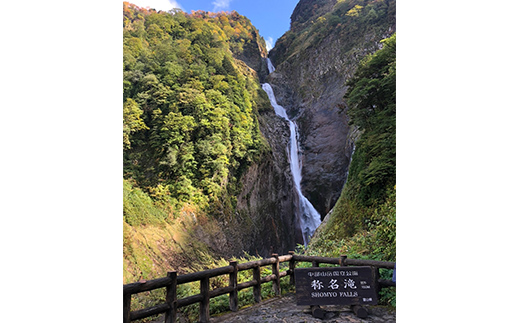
[262,58,321,246]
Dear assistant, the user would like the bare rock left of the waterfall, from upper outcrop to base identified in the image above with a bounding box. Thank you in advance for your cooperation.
[225,43,303,256]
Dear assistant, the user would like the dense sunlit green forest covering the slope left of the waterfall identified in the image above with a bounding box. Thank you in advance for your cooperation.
[123,3,267,220]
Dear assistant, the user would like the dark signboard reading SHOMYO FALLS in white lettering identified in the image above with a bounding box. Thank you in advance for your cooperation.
[294,266,377,305]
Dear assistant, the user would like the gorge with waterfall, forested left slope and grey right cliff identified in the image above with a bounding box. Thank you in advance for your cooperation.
[123,0,395,294]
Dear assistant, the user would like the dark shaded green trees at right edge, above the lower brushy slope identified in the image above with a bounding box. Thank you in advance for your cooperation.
[345,34,396,206]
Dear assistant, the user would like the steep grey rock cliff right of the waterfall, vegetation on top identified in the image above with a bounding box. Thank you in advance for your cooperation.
[268,0,395,217]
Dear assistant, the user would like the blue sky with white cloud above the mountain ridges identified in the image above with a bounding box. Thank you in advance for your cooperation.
[127,0,299,49]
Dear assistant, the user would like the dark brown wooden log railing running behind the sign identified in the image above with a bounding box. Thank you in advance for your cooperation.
[123,251,395,323]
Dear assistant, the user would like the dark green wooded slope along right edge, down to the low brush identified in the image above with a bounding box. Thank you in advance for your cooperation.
[327,34,396,239]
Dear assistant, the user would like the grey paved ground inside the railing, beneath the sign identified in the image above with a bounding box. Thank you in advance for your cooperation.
[211,294,396,323]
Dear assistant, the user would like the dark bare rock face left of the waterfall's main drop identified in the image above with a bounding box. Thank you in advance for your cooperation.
[237,111,303,256]
